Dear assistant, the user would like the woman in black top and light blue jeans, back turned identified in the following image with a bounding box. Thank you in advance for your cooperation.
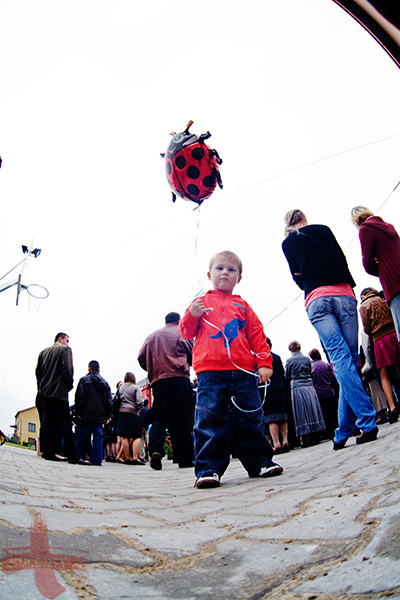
[282,209,378,450]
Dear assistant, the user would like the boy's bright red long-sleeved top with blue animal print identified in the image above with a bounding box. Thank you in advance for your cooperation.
[179,290,272,373]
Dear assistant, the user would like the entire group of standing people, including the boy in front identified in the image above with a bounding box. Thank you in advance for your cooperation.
[36,206,400,489]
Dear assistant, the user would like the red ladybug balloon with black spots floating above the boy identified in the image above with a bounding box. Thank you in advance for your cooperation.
[161,121,222,205]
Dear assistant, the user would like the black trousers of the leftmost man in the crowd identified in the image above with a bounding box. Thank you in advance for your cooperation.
[41,396,77,460]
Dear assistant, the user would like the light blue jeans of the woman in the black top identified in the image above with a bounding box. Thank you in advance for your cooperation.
[307,296,376,444]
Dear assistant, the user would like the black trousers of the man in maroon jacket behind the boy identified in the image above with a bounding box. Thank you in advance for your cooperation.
[149,377,193,467]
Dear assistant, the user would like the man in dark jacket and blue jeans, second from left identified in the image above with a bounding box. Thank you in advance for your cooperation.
[75,360,112,467]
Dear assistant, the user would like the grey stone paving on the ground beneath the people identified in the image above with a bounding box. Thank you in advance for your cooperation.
[0,423,400,600]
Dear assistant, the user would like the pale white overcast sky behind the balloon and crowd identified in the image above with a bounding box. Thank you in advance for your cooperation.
[0,0,400,433]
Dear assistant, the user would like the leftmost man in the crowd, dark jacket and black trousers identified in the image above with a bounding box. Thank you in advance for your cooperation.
[35,333,77,463]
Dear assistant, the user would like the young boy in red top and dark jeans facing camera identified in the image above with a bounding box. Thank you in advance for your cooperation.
[179,251,283,488]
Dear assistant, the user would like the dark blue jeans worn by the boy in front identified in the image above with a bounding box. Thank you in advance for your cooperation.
[194,371,275,477]
